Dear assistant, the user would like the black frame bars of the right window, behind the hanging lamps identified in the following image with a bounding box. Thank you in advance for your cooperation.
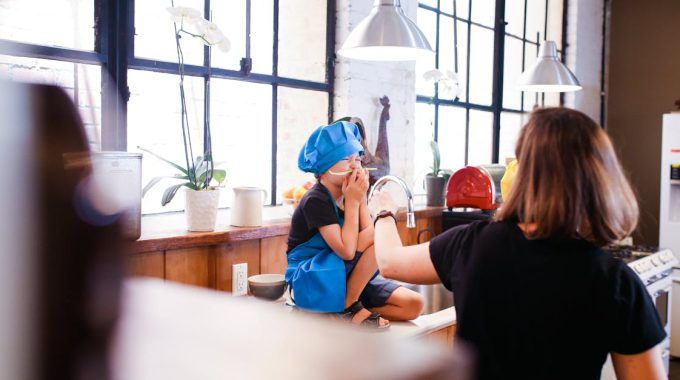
[416,0,568,166]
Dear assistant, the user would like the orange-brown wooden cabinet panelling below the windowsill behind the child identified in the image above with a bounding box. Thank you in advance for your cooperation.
[125,207,442,292]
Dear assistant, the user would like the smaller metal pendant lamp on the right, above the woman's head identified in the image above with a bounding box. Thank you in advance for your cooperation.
[517,41,582,92]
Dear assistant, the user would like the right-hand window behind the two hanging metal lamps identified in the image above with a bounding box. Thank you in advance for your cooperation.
[415,0,564,171]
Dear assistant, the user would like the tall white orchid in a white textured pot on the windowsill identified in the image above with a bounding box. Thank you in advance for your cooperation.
[138,7,230,231]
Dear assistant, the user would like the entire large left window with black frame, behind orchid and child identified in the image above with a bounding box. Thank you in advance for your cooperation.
[0,0,335,213]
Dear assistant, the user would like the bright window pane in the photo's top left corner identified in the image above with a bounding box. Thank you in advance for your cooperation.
[0,0,94,51]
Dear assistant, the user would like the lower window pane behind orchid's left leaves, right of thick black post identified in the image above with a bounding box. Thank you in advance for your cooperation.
[127,70,205,214]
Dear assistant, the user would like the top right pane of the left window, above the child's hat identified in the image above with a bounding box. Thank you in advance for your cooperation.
[279,0,326,82]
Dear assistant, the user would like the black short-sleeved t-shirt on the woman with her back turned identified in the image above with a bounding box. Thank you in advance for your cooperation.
[430,221,666,379]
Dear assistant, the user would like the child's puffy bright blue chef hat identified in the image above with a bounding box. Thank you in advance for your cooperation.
[298,121,364,174]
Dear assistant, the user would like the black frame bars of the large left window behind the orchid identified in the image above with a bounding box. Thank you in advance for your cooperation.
[0,0,336,206]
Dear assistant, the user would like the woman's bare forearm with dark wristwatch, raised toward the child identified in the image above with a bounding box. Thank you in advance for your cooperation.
[369,191,441,284]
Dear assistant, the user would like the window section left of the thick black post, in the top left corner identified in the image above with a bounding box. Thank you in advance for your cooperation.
[0,0,102,149]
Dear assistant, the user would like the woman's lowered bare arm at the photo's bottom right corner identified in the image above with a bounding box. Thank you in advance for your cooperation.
[612,346,667,380]
